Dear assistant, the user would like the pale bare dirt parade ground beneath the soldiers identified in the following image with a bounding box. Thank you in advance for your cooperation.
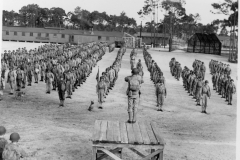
[0,44,238,160]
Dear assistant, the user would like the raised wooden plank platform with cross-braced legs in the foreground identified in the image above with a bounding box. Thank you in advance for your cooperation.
[92,120,165,160]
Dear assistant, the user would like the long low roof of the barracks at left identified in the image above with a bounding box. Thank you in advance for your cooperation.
[2,26,123,37]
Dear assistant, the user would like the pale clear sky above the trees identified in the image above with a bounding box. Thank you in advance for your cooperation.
[2,0,231,25]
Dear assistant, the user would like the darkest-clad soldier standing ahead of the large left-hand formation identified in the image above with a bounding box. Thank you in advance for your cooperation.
[57,75,66,107]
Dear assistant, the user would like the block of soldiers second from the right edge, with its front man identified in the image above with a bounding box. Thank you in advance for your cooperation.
[182,60,211,113]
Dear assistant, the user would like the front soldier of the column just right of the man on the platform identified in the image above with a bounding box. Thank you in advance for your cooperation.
[156,80,167,112]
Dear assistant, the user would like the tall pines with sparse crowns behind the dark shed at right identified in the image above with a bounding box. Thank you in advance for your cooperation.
[138,0,238,38]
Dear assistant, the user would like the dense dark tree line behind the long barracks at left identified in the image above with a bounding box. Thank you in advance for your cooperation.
[2,4,137,34]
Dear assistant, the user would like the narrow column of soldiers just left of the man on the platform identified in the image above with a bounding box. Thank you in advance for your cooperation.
[96,46,126,109]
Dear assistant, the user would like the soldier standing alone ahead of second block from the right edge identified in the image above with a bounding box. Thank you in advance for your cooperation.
[201,80,211,113]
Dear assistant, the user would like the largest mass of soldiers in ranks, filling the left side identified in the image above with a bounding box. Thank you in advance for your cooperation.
[1,42,106,106]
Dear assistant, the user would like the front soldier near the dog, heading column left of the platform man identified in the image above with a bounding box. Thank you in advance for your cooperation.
[96,76,107,109]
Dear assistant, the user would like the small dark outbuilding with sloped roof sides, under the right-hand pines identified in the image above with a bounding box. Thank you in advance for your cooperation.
[187,33,222,55]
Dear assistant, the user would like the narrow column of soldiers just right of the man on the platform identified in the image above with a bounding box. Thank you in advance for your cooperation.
[143,48,167,112]
